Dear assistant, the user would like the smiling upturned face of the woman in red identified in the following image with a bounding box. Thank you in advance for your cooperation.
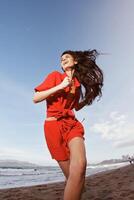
[61,53,77,71]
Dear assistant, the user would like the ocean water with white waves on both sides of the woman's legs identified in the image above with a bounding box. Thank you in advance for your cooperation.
[0,163,128,189]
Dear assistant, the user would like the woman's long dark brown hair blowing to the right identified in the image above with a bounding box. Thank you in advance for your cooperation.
[61,49,103,105]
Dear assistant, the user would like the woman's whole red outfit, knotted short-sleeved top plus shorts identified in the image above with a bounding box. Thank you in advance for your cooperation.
[34,71,85,161]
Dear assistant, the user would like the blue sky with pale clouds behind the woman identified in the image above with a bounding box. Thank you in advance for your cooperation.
[0,0,134,165]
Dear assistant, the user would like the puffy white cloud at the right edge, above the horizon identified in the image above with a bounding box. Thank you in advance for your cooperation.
[91,111,134,147]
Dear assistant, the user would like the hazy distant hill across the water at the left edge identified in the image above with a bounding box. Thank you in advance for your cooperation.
[0,160,39,169]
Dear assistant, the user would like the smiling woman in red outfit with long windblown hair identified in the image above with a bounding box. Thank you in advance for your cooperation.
[33,50,103,200]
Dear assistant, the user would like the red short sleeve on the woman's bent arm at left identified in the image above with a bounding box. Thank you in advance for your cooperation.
[34,71,58,92]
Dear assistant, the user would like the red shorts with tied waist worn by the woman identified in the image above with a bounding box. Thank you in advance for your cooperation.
[44,118,85,161]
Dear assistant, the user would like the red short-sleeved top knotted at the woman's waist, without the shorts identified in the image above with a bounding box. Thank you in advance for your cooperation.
[34,71,80,118]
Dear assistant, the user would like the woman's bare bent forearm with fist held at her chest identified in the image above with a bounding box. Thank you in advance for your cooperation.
[33,77,71,103]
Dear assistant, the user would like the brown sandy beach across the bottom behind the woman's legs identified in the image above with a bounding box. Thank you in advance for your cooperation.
[0,165,134,200]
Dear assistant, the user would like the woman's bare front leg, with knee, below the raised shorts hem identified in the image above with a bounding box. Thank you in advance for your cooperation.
[64,137,87,200]
